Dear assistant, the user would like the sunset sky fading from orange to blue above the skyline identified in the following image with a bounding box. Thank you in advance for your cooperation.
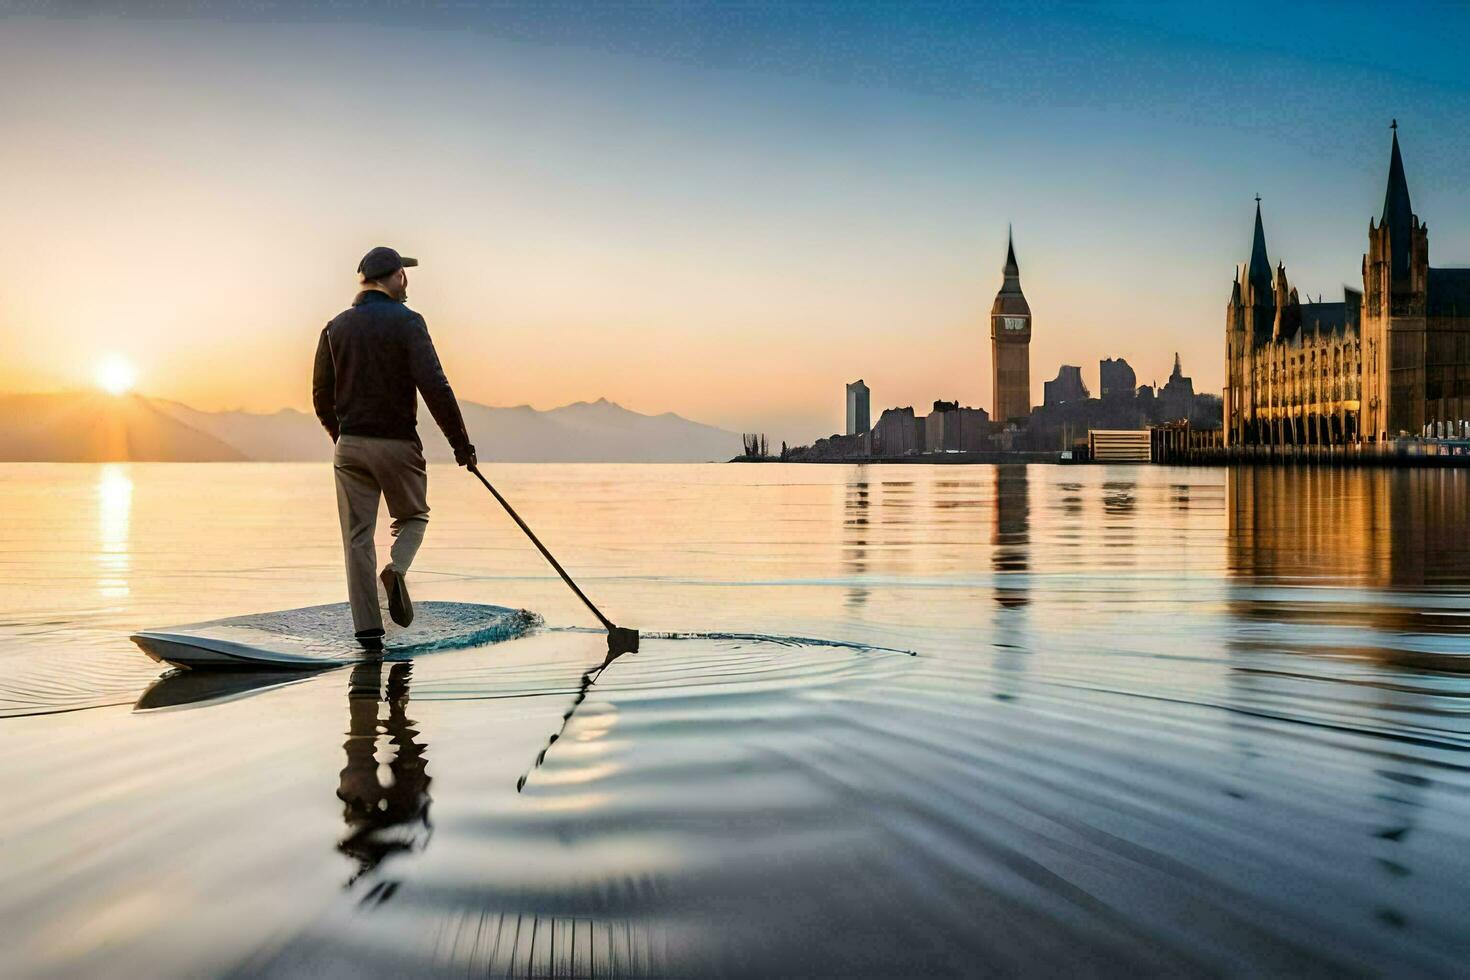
[0,0,1470,442]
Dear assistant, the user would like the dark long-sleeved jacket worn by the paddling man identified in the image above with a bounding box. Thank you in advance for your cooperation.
[312,289,475,457]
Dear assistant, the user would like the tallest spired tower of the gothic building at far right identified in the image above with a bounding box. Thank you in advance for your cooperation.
[1361,119,1429,439]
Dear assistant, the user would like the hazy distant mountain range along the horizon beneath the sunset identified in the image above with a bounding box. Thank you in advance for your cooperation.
[0,392,739,463]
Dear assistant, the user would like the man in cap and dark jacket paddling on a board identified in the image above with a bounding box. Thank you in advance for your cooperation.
[312,247,475,649]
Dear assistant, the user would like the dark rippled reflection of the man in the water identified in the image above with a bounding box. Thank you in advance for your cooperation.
[337,660,434,882]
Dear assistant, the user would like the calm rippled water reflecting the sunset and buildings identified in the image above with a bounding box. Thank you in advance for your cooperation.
[0,464,1470,976]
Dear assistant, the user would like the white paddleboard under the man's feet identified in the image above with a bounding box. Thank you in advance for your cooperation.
[131,602,541,670]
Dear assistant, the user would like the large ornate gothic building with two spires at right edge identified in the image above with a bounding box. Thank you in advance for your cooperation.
[1225,123,1470,445]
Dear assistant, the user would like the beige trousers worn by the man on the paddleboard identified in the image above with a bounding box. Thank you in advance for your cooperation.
[332,435,429,632]
